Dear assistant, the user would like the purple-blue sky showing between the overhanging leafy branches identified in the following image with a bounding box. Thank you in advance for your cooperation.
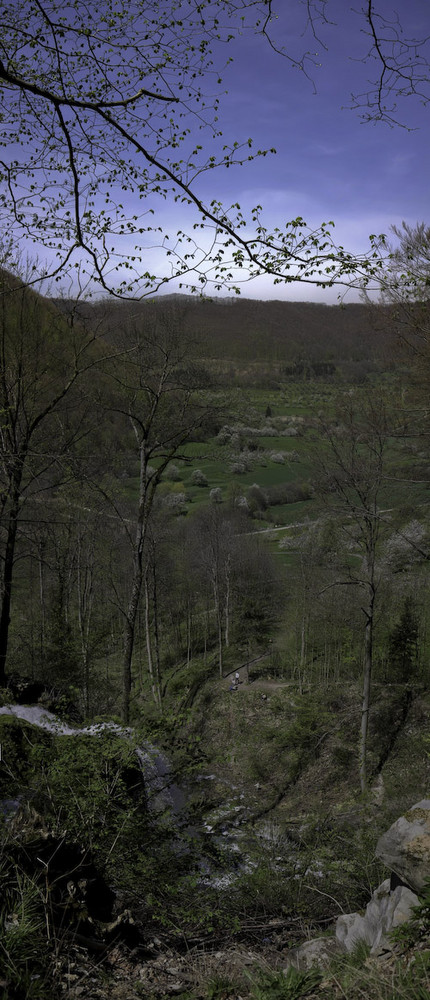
[4,0,430,303]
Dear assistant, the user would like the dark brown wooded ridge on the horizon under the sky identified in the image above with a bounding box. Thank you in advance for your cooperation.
[52,295,395,377]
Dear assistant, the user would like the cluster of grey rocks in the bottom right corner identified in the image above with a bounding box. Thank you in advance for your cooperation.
[287,799,430,969]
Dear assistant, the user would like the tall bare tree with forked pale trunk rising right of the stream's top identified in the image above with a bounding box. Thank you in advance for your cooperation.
[101,310,215,723]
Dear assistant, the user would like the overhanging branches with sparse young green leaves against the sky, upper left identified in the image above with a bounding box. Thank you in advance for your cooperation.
[0,0,428,294]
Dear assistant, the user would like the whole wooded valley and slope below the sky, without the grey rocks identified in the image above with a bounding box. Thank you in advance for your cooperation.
[0,262,430,1000]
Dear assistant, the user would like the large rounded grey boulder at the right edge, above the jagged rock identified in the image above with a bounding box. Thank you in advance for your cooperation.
[375,799,430,892]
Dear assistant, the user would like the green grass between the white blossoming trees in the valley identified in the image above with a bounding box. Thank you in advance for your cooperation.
[153,375,429,530]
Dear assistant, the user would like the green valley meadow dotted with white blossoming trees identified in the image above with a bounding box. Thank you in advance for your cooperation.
[127,375,429,556]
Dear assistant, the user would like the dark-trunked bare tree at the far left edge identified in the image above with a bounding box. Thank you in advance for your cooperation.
[0,272,95,685]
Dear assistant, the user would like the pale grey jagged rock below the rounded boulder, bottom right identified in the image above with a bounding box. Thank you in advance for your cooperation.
[336,878,418,954]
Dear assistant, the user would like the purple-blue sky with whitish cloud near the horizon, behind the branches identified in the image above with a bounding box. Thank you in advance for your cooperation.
[5,0,430,302]
